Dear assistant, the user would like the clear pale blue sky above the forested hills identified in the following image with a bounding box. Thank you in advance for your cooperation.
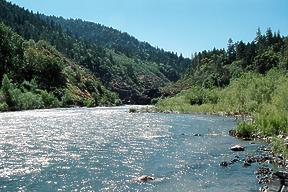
[11,0,288,56]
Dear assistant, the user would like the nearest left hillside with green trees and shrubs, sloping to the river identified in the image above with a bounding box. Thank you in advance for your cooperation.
[0,22,119,110]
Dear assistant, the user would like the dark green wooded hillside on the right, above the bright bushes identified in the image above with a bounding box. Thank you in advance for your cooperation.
[164,29,288,95]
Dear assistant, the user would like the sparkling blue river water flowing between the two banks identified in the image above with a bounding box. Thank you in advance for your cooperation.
[0,106,259,192]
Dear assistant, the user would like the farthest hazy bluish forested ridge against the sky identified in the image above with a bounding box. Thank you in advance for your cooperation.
[47,17,191,77]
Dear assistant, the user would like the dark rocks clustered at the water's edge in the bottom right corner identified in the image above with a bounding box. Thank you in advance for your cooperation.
[227,130,288,192]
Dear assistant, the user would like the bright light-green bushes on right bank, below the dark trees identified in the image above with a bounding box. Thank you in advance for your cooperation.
[155,69,288,189]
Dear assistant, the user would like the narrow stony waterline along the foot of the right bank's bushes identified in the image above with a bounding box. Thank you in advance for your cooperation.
[133,106,288,192]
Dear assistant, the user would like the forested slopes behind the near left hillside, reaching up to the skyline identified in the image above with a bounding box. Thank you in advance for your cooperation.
[0,0,191,104]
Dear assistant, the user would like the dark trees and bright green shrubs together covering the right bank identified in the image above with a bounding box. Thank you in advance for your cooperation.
[156,29,288,158]
